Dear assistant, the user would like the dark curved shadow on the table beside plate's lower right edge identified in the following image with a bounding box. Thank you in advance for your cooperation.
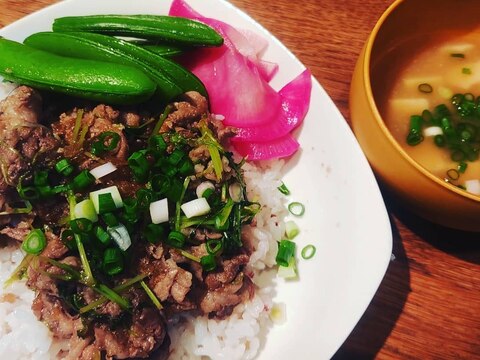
[332,205,410,360]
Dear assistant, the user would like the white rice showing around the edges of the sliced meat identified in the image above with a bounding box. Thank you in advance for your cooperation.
[0,157,287,360]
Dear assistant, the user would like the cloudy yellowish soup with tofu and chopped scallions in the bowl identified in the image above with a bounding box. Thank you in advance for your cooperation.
[379,28,480,194]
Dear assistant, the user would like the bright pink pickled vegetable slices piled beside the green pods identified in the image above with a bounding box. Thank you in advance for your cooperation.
[169,0,311,160]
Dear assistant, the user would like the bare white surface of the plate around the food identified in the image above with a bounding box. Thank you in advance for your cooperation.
[0,0,392,360]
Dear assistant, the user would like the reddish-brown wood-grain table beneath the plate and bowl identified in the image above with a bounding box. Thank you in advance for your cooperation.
[0,0,480,359]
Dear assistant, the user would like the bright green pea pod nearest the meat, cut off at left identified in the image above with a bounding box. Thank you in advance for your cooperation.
[0,38,156,104]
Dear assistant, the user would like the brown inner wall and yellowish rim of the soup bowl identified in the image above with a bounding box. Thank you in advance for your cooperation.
[367,0,480,201]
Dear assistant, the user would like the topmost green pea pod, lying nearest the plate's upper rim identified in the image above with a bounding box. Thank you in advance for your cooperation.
[53,15,223,46]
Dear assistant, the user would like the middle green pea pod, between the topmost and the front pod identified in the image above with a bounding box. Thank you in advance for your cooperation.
[24,32,207,101]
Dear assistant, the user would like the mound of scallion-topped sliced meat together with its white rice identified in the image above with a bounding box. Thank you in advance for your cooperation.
[0,86,286,359]
